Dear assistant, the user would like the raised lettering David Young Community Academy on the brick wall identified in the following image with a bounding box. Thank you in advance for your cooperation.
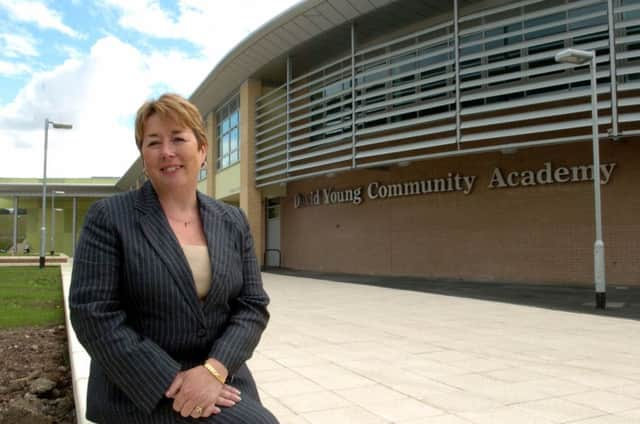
[294,162,616,208]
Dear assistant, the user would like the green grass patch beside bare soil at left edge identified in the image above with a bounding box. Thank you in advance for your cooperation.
[0,266,64,328]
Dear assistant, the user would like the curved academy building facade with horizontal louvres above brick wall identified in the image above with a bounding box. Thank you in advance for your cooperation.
[191,0,640,284]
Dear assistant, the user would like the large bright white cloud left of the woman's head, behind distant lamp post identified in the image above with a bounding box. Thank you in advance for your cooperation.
[0,36,215,177]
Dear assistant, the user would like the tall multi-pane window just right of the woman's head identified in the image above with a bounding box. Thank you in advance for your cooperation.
[216,96,240,169]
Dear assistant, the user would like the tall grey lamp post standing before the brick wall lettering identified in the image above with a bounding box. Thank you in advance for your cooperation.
[556,49,607,309]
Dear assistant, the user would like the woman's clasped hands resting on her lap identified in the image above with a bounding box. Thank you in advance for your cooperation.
[165,366,241,418]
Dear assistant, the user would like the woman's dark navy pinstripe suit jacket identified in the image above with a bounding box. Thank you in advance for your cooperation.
[69,182,269,420]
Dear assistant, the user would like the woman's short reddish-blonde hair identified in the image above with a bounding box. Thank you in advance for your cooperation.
[135,93,207,150]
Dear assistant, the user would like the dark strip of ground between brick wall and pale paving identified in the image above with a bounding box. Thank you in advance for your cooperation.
[264,267,640,320]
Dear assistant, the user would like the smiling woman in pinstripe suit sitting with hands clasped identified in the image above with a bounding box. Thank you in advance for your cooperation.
[69,94,277,424]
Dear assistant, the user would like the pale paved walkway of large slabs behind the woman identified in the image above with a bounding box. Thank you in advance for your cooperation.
[63,268,640,424]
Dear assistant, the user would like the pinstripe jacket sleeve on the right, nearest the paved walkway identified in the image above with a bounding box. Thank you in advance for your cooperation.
[209,208,269,375]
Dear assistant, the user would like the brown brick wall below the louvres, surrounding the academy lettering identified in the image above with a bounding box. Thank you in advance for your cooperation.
[281,139,640,285]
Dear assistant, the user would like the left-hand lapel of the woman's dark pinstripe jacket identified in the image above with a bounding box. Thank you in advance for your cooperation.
[136,181,205,324]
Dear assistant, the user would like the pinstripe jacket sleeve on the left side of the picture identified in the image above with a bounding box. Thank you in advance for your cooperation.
[69,201,180,413]
